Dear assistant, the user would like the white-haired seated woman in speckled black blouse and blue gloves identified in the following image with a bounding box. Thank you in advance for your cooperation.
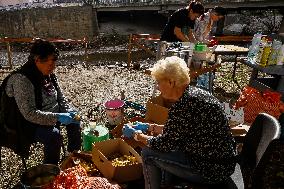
[122,56,236,189]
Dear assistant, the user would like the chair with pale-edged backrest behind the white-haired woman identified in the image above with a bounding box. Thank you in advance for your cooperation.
[170,113,281,189]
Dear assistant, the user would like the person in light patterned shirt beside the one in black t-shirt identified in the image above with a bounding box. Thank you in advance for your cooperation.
[194,6,226,43]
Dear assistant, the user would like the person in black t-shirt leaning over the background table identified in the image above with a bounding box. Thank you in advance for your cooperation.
[160,1,204,42]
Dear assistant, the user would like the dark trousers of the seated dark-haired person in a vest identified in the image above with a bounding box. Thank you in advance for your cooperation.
[35,124,82,165]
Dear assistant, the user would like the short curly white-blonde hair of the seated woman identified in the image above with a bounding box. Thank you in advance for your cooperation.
[150,56,190,86]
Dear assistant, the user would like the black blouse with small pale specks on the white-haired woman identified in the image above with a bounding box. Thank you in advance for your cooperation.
[148,87,236,183]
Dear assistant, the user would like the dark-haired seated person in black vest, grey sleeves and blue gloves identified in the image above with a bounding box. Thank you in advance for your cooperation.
[1,39,81,164]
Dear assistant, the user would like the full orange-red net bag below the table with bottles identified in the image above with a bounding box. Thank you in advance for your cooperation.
[233,86,284,123]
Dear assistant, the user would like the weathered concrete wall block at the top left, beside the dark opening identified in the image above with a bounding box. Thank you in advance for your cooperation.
[0,6,98,39]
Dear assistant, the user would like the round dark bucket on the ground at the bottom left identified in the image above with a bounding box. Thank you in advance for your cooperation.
[20,164,60,189]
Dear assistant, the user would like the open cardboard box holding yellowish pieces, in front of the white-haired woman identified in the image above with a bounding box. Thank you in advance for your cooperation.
[92,138,143,183]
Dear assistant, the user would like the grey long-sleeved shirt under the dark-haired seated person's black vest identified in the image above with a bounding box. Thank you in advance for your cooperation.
[5,73,73,125]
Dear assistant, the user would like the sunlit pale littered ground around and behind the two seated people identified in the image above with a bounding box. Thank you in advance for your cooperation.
[0,47,251,189]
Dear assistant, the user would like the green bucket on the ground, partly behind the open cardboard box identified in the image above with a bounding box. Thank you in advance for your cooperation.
[83,125,109,151]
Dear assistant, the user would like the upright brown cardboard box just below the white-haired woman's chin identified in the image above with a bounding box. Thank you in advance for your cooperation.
[145,95,169,125]
